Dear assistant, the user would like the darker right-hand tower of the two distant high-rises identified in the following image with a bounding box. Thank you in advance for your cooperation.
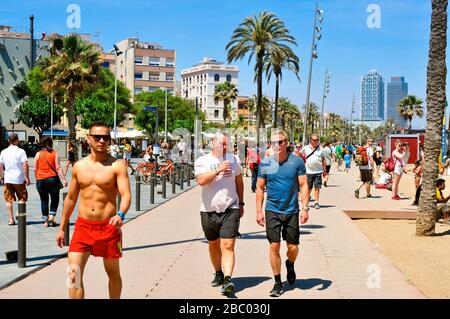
[386,76,408,128]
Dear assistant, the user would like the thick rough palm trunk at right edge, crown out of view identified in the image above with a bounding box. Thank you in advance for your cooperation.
[416,0,448,236]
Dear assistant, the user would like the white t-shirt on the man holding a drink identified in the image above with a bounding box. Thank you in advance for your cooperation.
[194,153,242,213]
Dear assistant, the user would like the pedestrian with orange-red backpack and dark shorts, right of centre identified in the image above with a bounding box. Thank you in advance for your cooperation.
[355,138,374,198]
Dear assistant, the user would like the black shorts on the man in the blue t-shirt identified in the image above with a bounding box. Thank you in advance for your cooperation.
[266,211,300,245]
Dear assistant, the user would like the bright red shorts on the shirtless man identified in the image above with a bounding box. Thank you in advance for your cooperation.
[69,217,122,259]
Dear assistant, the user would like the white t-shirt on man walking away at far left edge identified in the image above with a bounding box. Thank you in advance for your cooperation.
[0,145,28,184]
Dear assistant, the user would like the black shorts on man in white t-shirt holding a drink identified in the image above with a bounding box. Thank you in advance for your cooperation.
[200,208,240,241]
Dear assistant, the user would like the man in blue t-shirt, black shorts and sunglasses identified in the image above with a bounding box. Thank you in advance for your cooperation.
[256,130,309,297]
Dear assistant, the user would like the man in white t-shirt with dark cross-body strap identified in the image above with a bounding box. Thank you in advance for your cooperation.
[301,134,327,209]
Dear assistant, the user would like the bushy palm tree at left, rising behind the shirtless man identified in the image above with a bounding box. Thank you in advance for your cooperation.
[43,34,101,156]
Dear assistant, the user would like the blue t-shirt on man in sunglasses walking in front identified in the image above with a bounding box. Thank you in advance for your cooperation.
[258,154,306,214]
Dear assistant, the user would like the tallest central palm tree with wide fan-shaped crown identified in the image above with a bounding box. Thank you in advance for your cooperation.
[225,11,296,146]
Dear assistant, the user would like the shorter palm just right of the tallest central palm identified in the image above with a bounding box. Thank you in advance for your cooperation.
[264,48,300,128]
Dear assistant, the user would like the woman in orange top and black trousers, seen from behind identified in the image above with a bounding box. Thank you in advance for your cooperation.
[34,136,67,227]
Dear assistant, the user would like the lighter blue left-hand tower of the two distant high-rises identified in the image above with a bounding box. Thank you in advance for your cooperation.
[361,70,384,122]
